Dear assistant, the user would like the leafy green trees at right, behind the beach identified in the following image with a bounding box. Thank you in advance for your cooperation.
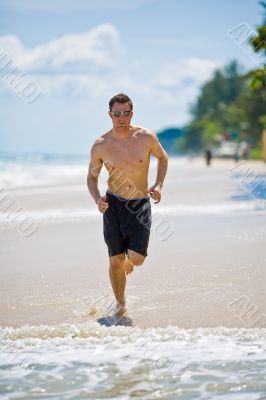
[181,1,266,157]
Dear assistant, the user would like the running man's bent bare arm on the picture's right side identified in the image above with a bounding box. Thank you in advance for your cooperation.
[149,133,168,204]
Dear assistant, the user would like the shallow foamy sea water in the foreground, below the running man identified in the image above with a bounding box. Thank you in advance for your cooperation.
[0,321,266,400]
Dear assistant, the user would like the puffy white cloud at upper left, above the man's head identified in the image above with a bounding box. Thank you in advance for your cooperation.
[0,23,120,74]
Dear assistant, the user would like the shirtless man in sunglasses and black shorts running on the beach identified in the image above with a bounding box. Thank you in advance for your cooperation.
[87,93,168,316]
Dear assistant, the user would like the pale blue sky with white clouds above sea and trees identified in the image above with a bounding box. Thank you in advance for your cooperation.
[0,0,263,154]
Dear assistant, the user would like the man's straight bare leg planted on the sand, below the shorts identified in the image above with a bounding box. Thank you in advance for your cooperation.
[109,253,126,317]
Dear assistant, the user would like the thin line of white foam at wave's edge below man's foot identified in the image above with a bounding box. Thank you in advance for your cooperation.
[0,320,266,340]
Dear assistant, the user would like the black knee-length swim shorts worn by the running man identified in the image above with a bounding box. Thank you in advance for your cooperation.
[103,191,151,257]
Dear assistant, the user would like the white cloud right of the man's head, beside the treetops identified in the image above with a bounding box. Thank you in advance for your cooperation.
[127,58,221,127]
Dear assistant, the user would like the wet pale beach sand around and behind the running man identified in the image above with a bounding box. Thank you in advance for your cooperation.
[0,159,266,328]
